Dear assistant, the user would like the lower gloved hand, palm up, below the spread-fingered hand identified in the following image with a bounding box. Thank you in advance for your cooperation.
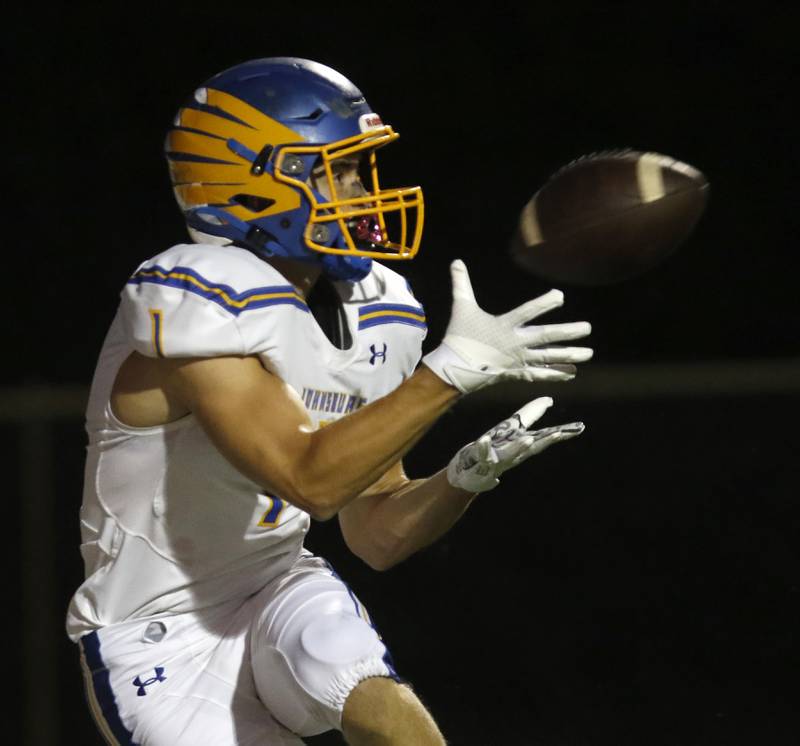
[447,396,584,492]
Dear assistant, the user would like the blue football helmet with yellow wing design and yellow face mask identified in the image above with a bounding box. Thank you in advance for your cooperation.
[165,57,424,280]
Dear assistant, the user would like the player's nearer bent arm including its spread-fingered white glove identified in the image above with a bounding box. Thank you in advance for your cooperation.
[163,262,591,519]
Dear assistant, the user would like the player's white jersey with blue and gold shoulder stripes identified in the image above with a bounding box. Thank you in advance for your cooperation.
[67,244,426,640]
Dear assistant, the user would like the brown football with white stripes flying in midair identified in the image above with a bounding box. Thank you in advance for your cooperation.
[511,150,708,285]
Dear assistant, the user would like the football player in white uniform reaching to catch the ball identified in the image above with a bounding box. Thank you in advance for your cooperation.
[67,58,591,746]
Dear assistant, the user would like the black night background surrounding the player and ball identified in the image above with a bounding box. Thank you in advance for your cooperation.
[7,2,800,746]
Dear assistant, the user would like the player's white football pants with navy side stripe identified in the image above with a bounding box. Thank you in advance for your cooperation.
[79,553,397,746]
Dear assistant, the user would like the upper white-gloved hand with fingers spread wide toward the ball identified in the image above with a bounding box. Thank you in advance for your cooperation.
[422,259,592,394]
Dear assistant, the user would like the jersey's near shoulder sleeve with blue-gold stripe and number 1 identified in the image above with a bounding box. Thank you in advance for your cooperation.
[120,244,308,357]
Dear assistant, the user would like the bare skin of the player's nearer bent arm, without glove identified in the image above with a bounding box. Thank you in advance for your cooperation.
[166,357,458,520]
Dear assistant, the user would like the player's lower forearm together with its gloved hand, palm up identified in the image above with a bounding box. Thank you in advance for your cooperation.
[339,397,584,570]
